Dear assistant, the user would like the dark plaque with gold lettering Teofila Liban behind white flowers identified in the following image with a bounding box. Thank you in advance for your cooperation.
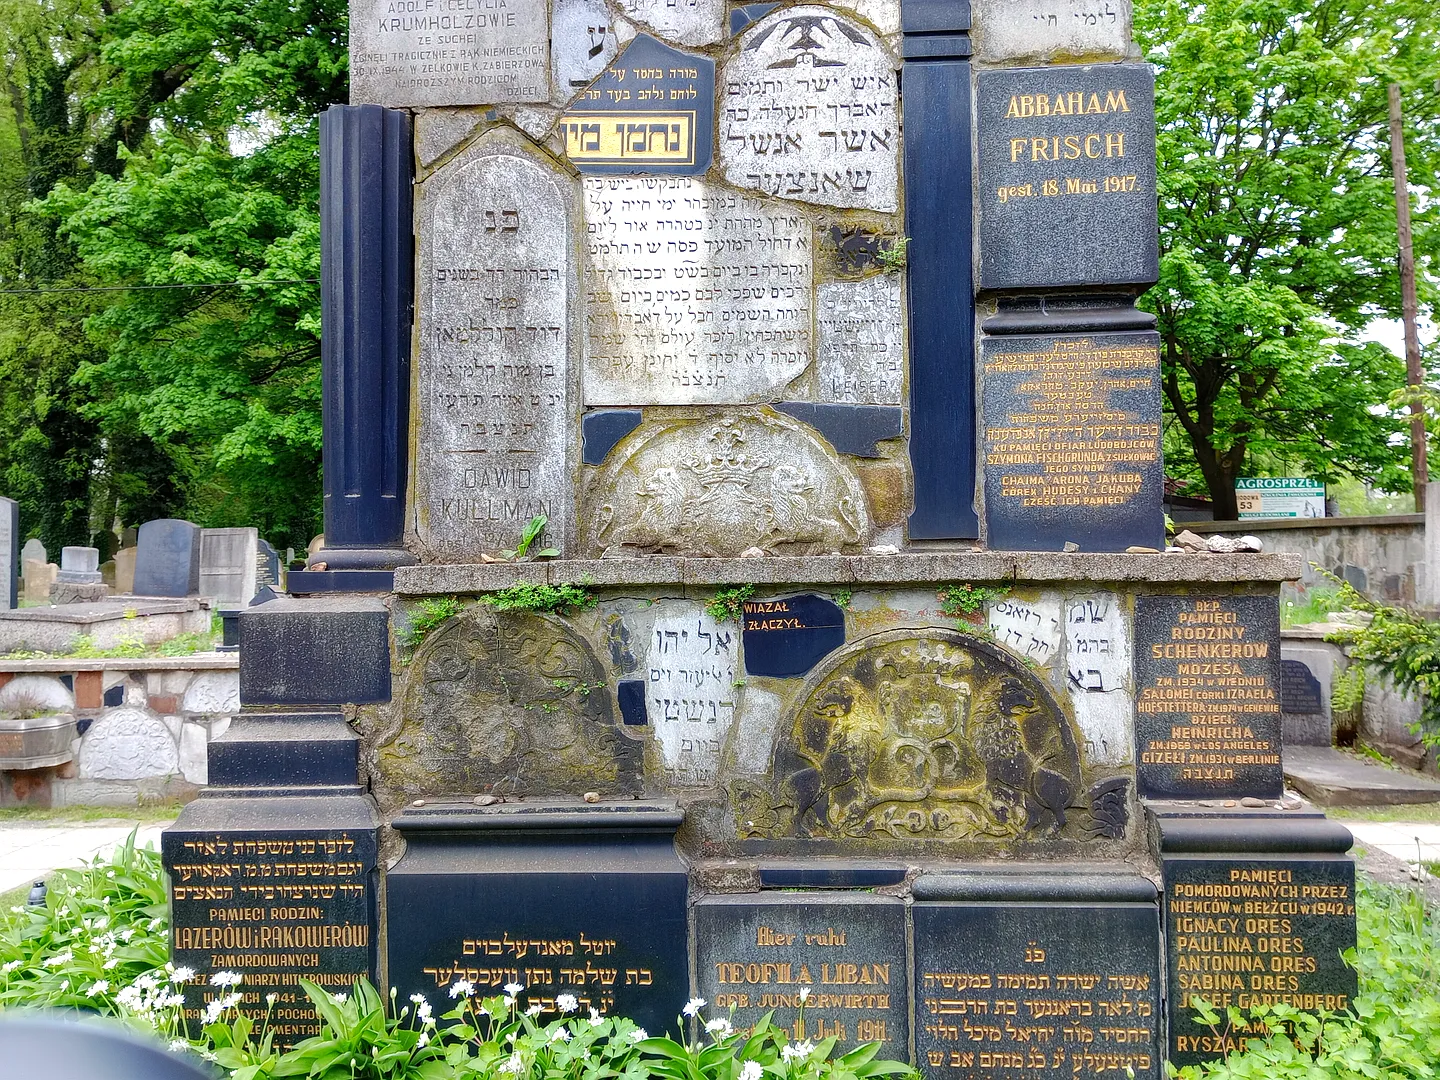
[694,893,910,1058]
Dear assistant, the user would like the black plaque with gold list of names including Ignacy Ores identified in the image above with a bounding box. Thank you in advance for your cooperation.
[1162,855,1355,1066]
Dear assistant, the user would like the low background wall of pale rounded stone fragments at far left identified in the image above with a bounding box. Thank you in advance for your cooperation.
[0,665,240,806]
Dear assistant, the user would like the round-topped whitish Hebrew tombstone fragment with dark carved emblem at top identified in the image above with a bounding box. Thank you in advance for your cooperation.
[719,6,900,210]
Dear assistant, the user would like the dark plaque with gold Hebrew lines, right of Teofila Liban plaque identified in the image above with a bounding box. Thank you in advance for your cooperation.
[914,901,1161,1080]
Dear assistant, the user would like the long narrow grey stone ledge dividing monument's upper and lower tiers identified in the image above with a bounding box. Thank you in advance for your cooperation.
[395,552,1302,596]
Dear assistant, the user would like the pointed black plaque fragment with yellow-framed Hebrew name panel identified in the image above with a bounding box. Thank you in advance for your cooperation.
[560,33,716,176]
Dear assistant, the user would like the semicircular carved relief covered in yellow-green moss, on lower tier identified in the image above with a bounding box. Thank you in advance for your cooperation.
[730,629,1096,842]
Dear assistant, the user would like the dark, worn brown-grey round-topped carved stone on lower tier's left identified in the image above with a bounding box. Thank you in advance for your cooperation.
[372,609,644,802]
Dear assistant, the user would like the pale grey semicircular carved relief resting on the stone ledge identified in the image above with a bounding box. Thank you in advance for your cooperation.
[585,409,870,556]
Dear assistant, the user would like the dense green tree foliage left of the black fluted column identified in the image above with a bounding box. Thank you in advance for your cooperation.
[0,0,347,547]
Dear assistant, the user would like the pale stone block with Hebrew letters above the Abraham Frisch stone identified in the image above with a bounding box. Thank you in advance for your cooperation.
[975,0,1132,63]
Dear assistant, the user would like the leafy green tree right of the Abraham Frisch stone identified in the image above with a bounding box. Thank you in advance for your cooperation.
[1135,0,1440,518]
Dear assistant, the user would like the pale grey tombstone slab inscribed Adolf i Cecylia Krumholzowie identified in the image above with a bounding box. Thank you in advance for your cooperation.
[350,0,550,105]
